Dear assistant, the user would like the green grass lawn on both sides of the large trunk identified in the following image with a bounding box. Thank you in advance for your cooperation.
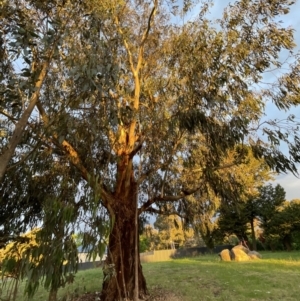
[1,252,300,301]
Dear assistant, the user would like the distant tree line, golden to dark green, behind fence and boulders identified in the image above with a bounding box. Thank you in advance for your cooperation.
[140,184,300,252]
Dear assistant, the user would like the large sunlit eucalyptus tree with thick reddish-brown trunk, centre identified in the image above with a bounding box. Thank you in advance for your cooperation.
[3,0,300,301]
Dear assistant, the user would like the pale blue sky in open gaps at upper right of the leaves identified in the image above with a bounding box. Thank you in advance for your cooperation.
[191,0,300,200]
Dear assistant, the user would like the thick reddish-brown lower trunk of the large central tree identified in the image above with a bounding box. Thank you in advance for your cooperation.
[101,180,147,301]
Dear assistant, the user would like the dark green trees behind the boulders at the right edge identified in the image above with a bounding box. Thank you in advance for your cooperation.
[214,184,299,251]
